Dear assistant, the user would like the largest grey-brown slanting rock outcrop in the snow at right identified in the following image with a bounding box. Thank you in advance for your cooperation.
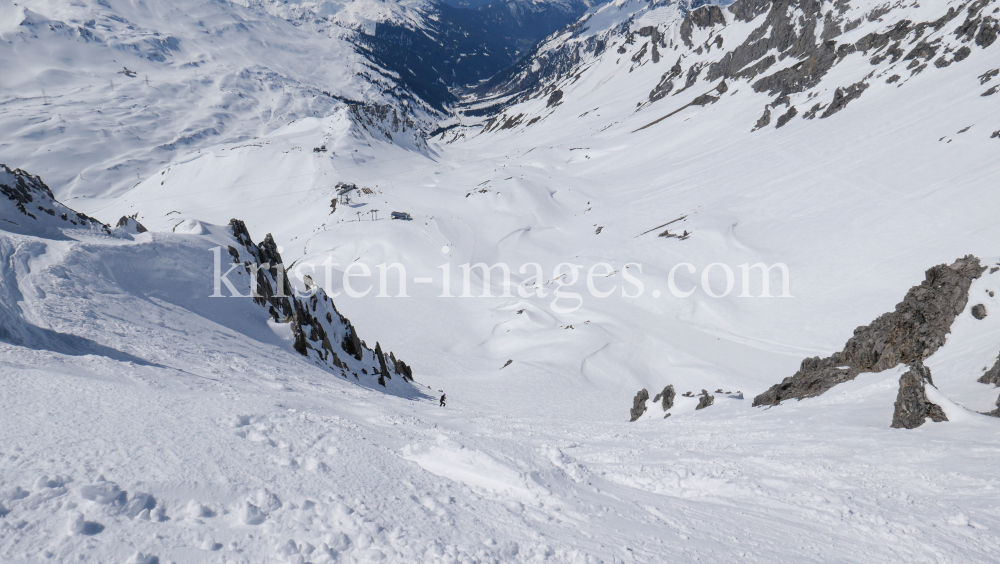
[753,255,986,407]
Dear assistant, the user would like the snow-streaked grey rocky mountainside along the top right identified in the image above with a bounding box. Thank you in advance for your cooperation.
[465,0,1000,135]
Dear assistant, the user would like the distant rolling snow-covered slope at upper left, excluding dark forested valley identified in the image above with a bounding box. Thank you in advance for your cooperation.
[0,0,436,201]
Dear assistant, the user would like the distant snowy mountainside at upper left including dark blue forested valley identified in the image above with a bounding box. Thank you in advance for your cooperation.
[0,0,585,204]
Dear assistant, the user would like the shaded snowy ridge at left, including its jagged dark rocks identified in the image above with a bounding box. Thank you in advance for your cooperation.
[0,165,415,395]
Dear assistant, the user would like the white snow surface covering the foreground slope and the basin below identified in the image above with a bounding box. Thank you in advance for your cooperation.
[0,2,1000,563]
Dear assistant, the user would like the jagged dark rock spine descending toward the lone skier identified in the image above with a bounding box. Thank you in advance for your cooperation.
[229,219,413,387]
